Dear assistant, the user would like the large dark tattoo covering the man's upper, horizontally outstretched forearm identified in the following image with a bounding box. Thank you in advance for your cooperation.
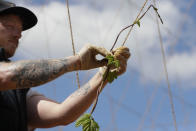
[11,59,75,88]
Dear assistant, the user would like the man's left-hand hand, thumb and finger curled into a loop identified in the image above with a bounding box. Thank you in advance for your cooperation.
[78,45,111,70]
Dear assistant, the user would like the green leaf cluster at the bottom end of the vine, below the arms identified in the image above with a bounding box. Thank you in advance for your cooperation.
[75,114,99,131]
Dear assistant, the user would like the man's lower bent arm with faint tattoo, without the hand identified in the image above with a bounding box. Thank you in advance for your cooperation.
[27,73,107,128]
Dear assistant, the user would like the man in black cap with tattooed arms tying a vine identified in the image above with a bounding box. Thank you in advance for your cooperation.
[0,1,130,131]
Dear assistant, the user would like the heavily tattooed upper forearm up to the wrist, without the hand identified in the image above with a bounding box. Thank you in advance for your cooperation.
[0,56,81,90]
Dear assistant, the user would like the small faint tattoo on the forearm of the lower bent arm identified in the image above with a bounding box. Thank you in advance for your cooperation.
[71,83,91,97]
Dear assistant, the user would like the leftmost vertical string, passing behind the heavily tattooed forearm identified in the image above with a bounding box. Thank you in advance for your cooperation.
[66,0,80,88]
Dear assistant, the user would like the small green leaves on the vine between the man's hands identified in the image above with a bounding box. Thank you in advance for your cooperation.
[104,55,120,83]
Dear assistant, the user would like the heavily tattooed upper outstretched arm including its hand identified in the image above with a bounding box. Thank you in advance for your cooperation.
[0,45,110,91]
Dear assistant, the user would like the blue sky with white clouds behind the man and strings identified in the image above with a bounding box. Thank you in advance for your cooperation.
[10,0,196,131]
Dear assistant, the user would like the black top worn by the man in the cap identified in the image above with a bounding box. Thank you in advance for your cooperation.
[0,48,29,131]
